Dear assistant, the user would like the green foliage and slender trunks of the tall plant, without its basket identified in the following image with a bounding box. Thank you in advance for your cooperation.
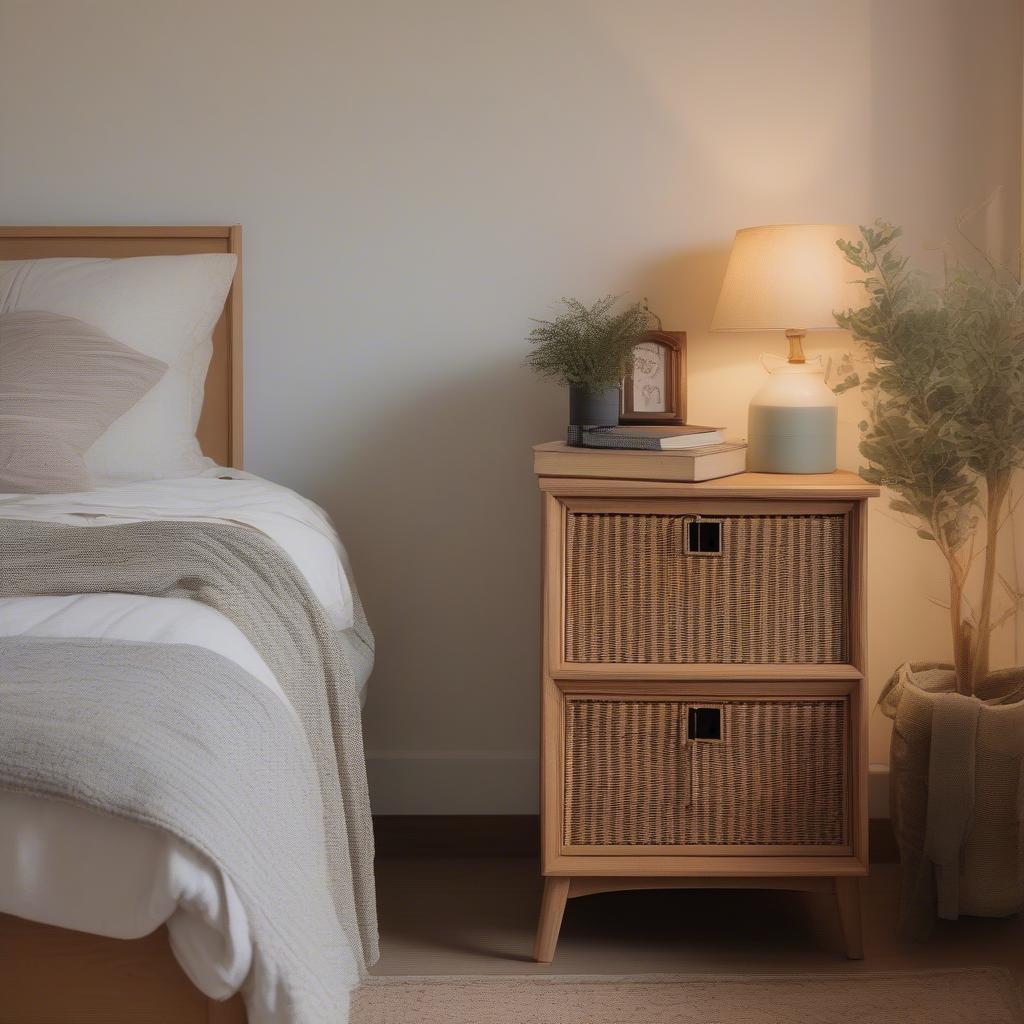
[836,221,1024,683]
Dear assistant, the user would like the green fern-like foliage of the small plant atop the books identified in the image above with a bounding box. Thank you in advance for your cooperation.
[526,295,648,391]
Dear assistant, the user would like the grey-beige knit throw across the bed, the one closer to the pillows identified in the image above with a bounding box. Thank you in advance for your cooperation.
[0,519,378,972]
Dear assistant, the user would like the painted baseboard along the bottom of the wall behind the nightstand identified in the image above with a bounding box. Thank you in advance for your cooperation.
[367,751,889,818]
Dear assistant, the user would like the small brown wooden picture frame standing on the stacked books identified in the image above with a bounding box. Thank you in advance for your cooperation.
[618,331,686,426]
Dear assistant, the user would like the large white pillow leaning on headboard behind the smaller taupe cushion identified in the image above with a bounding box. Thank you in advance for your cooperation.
[0,253,237,482]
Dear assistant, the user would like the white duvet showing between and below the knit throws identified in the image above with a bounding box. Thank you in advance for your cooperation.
[0,469,369,1015]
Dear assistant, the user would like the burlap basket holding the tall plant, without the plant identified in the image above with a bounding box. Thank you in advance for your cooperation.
[879,663,1024,935]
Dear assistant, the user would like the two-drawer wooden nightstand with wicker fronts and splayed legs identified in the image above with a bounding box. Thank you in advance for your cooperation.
[535,443,878,962]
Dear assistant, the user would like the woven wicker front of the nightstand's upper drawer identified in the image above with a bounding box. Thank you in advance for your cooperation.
[565,513,847,665]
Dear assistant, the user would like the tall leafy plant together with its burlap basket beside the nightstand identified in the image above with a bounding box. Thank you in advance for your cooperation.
[837,221,1024,931]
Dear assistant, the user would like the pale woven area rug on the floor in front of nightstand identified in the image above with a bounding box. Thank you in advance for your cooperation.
[351,968,1024,1024]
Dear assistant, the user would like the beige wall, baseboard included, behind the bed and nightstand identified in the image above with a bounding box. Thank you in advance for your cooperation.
[0,0,1021,812]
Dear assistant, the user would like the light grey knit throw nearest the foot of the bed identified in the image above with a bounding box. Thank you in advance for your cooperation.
[0,637,358,1024]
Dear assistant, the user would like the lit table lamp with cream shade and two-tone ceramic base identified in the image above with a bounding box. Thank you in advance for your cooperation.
[712,224,864,473]
